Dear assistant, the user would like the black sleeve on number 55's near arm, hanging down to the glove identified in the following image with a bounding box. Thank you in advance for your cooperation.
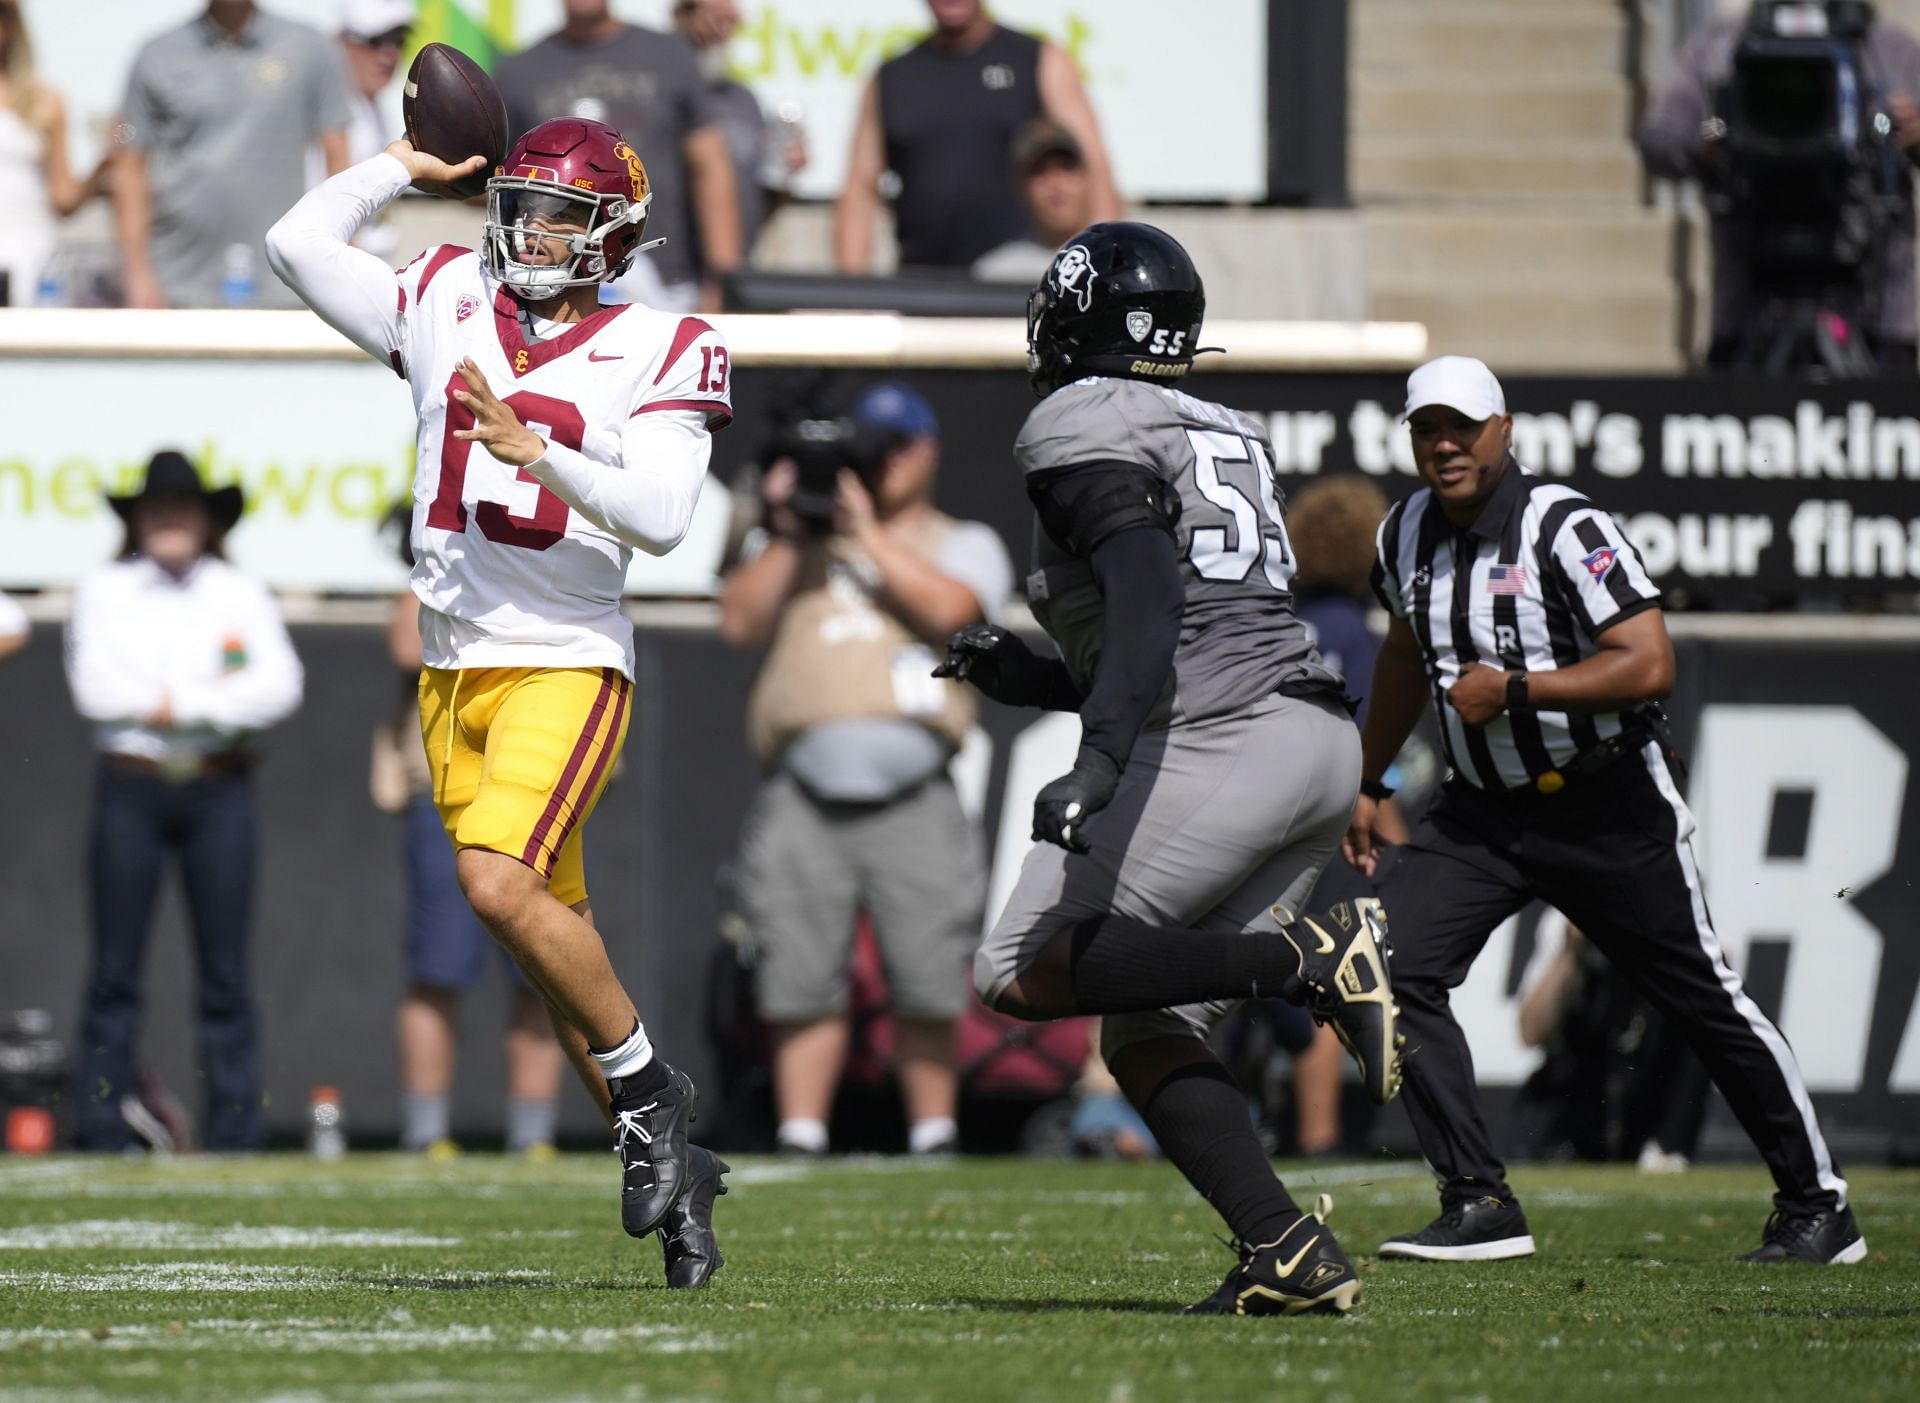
[1079,528,1187,770]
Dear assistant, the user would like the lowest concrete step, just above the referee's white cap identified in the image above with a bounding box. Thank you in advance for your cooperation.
[1369,282,1682,374]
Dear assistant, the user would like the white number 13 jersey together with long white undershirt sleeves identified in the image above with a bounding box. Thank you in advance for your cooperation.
[267,154,732,678]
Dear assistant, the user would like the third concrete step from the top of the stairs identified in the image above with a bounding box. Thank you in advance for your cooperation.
[1348,132,1640,203]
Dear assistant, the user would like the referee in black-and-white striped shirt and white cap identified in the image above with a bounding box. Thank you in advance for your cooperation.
[1346,355,1866,1263]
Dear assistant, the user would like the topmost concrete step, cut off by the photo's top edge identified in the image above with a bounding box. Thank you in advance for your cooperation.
[1352,0,1626,77]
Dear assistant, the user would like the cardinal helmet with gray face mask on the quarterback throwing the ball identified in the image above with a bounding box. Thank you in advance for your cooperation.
[482,117,664,301]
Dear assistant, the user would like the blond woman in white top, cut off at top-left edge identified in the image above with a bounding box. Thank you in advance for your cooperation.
[0,0,108,307]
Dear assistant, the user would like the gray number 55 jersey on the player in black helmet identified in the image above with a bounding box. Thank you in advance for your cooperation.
[1014,376,1342,722]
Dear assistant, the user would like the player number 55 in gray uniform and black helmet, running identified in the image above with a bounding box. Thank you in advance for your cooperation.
[941,223,1400,1315]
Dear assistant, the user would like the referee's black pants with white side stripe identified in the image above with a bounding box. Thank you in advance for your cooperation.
[1380,741,1847,1209]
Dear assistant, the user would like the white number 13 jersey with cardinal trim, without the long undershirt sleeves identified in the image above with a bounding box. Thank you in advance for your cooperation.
[394,246,732,676]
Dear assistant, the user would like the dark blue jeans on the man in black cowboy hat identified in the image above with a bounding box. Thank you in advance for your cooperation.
[75,764,265,1150]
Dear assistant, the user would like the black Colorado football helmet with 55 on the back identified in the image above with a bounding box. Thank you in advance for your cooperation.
[1027,219,1206,397]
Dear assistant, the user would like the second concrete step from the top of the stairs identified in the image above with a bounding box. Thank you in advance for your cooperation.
[1350,73,1630,142]
